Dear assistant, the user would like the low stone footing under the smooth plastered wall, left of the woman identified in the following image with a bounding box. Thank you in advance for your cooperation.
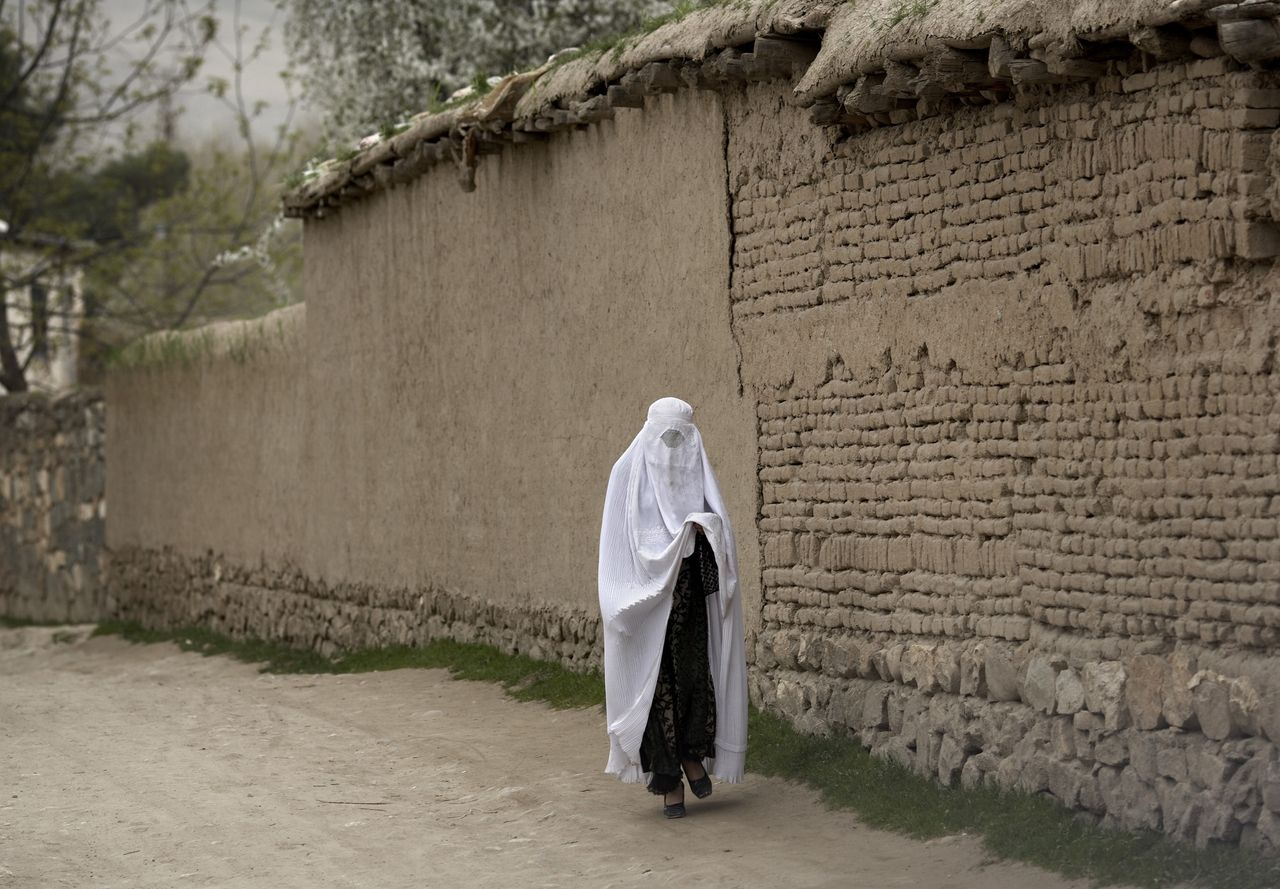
[109,547,603,670]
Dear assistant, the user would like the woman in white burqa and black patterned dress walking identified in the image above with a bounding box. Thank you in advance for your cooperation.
[599,398,746,817]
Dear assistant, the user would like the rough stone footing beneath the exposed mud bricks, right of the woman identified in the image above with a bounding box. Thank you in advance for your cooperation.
[751,628,1280,852]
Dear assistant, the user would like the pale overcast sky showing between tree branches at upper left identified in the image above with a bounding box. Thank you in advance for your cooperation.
[102,0,317,147]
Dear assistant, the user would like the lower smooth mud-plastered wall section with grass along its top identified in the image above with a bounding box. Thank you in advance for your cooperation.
[106,306,307,564]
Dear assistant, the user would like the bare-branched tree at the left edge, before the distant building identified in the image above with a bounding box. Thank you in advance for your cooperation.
[0,0,216,391]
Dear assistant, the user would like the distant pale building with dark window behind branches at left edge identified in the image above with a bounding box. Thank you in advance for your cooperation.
[0,220,84,394]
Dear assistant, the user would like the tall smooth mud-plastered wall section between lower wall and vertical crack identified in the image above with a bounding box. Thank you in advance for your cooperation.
[302,91,759,611]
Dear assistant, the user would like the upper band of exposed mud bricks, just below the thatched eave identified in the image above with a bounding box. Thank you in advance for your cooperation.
[732,60,1280,320]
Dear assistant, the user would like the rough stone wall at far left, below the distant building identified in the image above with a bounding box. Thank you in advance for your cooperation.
[0,393,106,622]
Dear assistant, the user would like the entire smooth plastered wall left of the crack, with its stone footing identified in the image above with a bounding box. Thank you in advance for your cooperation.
[109,92,760,665]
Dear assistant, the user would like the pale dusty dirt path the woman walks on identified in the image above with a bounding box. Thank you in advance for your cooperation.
[0,629,1085,889]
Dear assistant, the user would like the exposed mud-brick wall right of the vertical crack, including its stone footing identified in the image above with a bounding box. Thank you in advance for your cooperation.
[730,60,1280,847]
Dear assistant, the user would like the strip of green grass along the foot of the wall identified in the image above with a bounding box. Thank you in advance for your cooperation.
[95,622,1280,889]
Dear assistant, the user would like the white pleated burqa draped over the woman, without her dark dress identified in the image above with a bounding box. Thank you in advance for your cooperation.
[599,398,746,783]
